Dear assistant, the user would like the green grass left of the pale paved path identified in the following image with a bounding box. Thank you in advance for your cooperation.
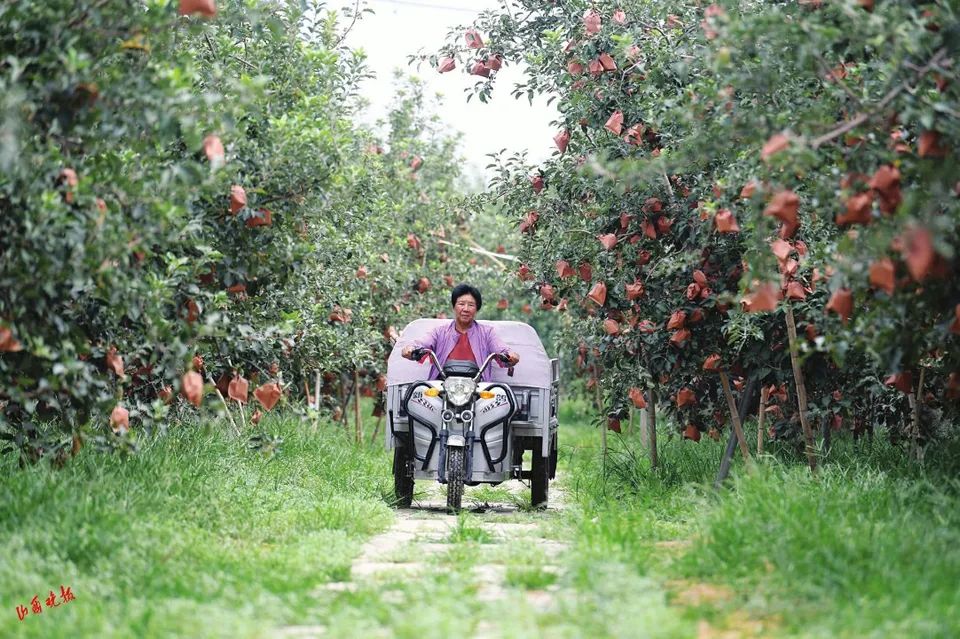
[0,420,393,637]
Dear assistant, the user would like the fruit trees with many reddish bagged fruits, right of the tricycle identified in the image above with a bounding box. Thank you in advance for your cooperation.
[434,0,960,461]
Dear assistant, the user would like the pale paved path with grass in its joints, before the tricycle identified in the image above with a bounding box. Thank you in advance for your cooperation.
[280,478,568,639]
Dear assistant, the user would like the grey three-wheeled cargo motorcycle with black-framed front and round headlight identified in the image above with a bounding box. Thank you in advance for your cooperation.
[386,319,560,511]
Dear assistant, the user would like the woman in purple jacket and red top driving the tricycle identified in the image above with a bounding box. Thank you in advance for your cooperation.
[401,284,520,382]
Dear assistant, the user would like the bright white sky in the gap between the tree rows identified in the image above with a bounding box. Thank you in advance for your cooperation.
[328,0,557,189]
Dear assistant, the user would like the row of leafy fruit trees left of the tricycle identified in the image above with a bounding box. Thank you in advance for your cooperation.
[0,0,520,460]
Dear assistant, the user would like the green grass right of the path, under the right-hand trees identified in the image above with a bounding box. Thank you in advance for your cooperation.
[574,410,960,637]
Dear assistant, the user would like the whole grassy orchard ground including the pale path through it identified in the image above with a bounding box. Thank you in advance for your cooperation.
[0,401,960,637]
